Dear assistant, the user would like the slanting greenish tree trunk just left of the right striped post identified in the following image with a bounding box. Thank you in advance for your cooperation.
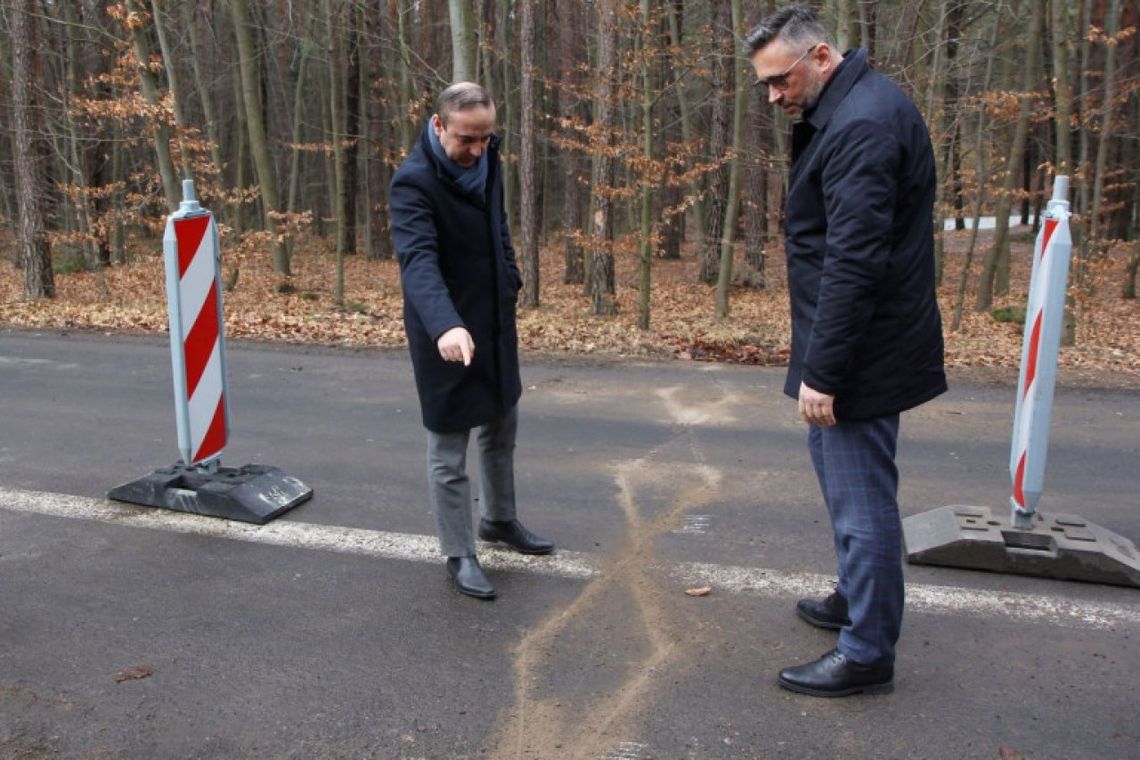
[974,0,1044,311]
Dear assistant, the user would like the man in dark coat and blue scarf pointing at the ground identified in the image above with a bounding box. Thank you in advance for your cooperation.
[389,82,554,599]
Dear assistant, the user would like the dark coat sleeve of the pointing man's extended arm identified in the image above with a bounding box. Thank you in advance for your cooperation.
[389,172,464,341]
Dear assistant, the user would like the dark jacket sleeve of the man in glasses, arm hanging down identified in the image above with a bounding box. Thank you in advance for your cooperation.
[804,121,901,394]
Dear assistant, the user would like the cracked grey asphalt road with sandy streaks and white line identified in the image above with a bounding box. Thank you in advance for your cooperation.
[0,332,1140,760]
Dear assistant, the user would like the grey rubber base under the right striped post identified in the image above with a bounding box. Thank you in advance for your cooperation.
[903,505,1140,588]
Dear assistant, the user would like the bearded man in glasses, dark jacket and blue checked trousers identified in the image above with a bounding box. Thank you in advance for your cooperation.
[747,6,946,696]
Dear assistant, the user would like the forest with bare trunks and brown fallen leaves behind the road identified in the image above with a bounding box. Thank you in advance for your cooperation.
[0,0,1140,386]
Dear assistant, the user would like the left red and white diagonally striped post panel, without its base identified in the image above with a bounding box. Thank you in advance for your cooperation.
[162,180,229,467]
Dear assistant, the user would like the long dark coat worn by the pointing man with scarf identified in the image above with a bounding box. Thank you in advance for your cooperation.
[389,125,522,433]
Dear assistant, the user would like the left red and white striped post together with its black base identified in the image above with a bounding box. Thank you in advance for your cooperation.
[107,180,312,525]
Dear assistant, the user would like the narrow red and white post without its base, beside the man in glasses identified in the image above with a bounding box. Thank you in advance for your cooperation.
[1009,177,1073,529]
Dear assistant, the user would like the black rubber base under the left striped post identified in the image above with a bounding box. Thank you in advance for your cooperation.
[107,463,312,525]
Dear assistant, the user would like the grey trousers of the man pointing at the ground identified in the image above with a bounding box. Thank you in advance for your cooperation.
[428,406,519,557]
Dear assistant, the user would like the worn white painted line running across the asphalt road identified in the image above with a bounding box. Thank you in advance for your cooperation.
[0,488,1140,629]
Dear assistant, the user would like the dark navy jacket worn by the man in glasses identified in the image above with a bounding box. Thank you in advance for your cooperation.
[784,50,946,419]
